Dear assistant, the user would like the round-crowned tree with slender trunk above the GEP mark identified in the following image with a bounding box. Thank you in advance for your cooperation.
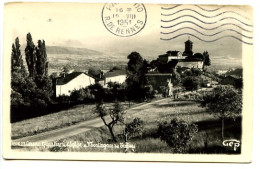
[201,86,242,140]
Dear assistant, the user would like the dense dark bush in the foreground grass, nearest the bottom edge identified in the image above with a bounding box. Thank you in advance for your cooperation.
[158,119,198,153]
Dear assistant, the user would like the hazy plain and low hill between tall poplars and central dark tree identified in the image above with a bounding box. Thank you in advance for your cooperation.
[46,46,127,74]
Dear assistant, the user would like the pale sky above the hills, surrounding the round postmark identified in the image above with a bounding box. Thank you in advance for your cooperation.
[4,3,253,67]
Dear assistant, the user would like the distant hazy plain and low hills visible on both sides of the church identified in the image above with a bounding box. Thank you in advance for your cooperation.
[21,45,241,72]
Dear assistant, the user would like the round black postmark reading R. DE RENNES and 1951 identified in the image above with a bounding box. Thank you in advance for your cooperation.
[102,3,147,37]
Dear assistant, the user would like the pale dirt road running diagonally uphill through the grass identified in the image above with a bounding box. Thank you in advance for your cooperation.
[13,98,172,143]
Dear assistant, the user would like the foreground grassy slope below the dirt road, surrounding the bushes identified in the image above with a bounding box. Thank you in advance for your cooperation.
[15,101,241,154]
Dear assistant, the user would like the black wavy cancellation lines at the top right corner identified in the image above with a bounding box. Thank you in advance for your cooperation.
[161,5,253,45]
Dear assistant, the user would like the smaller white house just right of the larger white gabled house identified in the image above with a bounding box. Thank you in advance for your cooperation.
[104,69,126,87]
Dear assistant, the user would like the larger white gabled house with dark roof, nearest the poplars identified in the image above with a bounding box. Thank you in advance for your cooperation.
[55,72,95,97]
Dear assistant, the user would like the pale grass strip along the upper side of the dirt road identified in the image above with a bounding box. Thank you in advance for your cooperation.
[11,102,139,139]
